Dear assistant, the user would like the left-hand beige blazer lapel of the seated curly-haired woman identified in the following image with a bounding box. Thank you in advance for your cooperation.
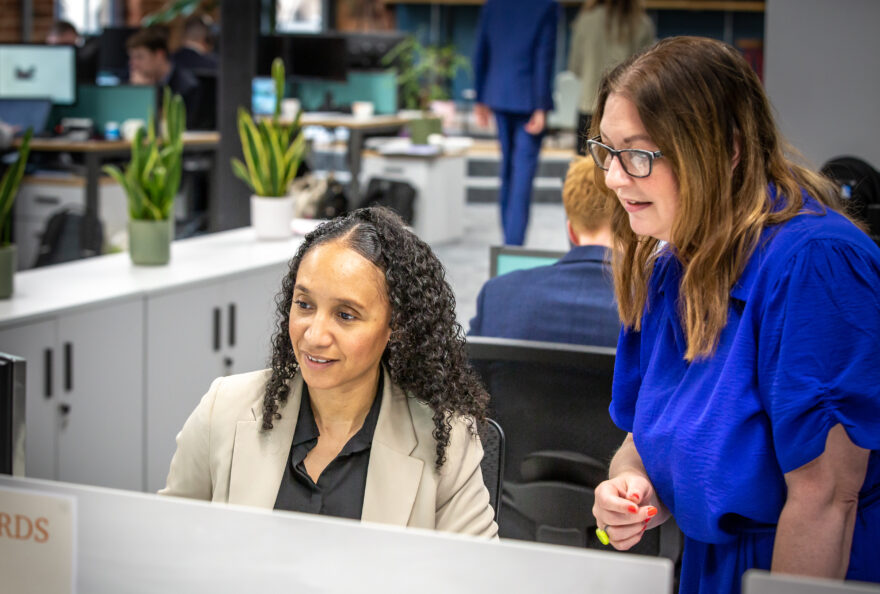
[228,374,302,509]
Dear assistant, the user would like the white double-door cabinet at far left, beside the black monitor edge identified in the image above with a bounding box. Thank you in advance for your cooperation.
[0,299,144,490]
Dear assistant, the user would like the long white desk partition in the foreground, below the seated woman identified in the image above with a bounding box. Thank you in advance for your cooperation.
[0,476,672,594]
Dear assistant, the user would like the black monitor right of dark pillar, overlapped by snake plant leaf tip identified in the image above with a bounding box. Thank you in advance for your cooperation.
[257,33,348,82]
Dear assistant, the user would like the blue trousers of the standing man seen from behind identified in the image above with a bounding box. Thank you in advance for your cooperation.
[495,111,544,245]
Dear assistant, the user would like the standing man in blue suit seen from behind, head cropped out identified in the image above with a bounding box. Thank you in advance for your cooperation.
[474,0,561,245]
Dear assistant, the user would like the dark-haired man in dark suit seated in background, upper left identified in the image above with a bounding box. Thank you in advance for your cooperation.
[125,27,201,129]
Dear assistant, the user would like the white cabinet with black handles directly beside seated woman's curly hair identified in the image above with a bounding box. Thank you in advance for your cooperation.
[145,264,287,491]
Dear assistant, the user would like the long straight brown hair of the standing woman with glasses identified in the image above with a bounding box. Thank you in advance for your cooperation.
[591,37,842,361]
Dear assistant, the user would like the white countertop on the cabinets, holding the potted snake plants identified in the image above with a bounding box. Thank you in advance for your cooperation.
[0,221,312,326]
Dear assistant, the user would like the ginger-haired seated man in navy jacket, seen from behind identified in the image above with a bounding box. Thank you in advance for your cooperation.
[470,158,620,347]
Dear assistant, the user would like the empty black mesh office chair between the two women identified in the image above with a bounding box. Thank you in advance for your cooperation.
[467,336,682,562]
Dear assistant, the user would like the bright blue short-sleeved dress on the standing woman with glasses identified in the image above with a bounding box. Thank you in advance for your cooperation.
[610,187,880,594]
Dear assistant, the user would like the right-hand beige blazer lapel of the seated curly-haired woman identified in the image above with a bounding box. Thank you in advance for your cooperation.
[361,368,424,526]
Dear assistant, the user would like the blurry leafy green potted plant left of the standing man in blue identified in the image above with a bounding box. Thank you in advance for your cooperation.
[382,37,470,144]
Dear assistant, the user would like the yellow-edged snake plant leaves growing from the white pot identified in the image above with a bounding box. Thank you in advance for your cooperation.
[232,58,306,197]
